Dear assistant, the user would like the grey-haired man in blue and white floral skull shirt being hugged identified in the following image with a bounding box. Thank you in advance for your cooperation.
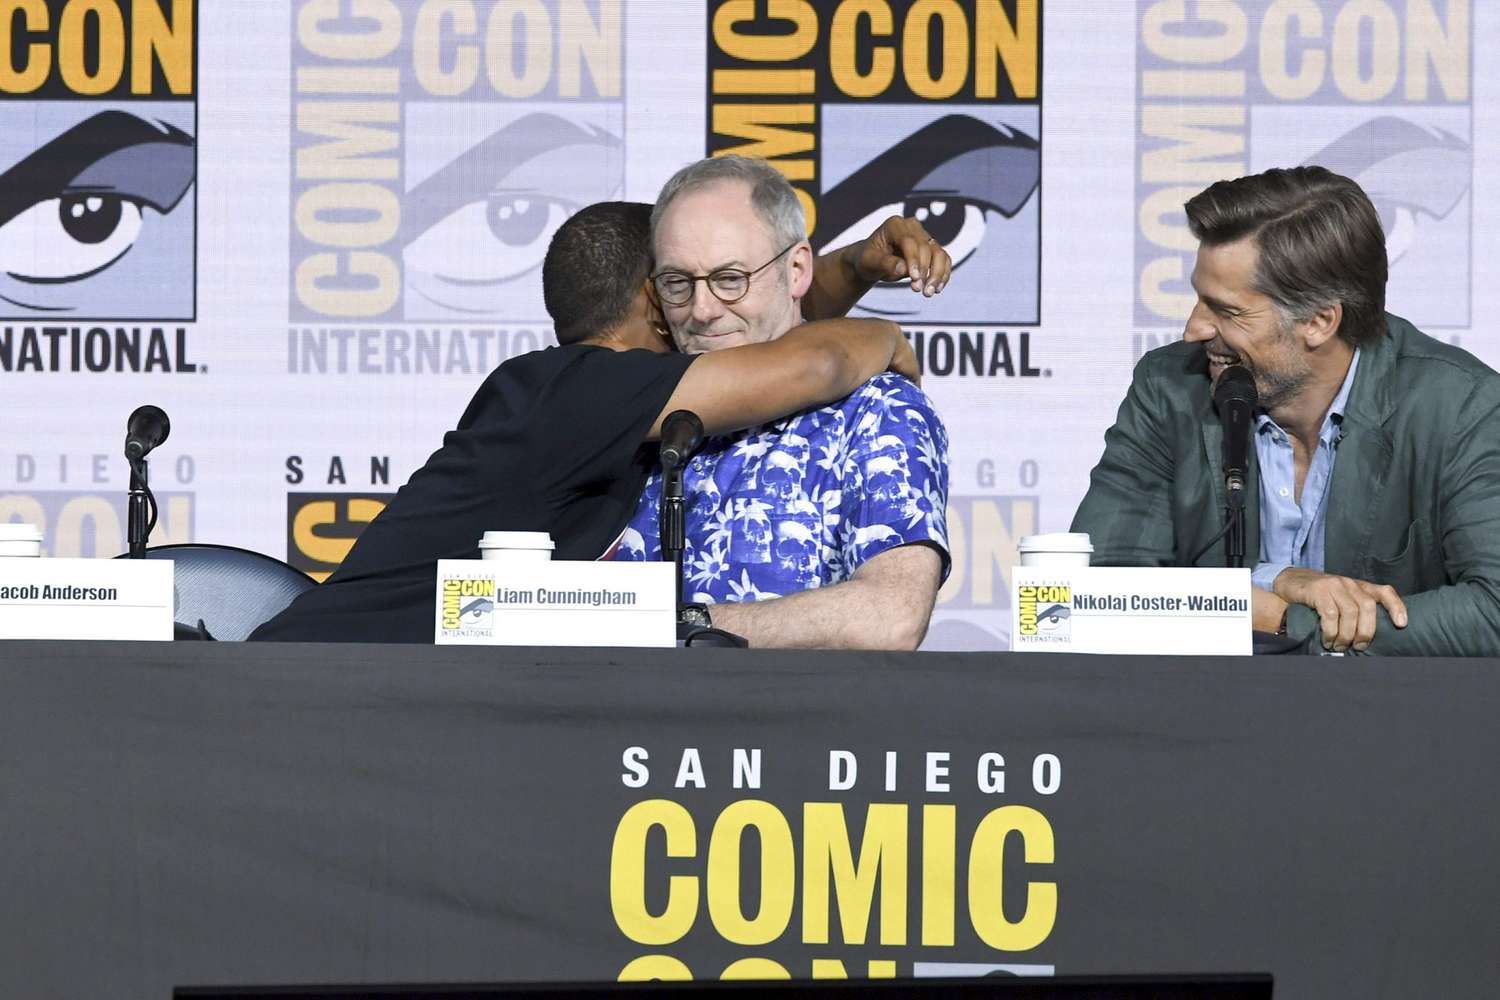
[612,156,950,649]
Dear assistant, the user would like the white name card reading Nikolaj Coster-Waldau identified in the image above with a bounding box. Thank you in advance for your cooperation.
[1011,567,1251,655]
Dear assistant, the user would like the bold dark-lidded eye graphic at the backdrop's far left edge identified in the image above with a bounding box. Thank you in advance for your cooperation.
[0,111,195,312]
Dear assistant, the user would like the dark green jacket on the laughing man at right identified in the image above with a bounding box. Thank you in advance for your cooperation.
[1073,315,1500,657]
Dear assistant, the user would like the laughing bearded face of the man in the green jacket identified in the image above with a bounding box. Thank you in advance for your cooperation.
[1182,238,1313,409]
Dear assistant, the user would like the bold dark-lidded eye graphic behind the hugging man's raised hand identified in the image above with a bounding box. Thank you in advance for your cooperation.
[813,114,1041,315]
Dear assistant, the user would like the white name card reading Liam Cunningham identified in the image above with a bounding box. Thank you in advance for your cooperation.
[434,559,677,648]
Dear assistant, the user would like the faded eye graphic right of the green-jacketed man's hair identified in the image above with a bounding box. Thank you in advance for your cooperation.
[1305,115,1473,264]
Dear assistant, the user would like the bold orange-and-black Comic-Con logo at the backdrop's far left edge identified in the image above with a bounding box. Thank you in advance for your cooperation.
[0,0,198,372]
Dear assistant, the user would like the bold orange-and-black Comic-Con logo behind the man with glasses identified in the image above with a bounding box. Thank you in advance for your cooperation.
[707,0,1041,328]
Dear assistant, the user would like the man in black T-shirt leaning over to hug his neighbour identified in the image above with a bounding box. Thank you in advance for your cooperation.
[251,202,932,643]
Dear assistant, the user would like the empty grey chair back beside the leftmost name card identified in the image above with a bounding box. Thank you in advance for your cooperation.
[116,544,318,642]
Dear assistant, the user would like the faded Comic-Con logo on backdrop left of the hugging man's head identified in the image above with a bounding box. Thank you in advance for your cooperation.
[288,0,626,373]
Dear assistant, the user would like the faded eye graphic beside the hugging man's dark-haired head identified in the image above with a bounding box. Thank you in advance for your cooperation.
[402,114,621,313]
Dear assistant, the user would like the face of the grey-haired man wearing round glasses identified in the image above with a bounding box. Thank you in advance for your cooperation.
[656,181,812,354]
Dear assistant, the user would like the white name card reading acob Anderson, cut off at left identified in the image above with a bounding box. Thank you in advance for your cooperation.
[0,558,173,640]
